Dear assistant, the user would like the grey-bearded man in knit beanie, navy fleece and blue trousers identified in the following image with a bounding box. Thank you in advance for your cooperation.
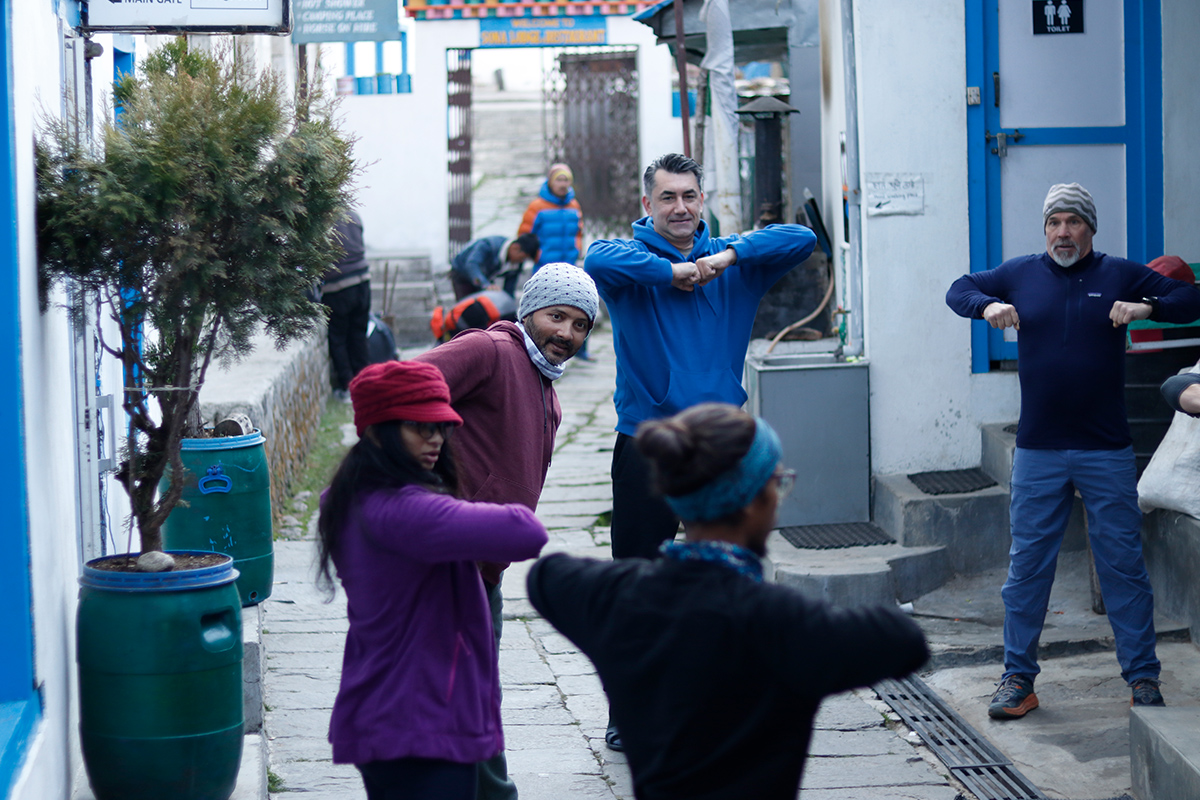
[946,184,1200,720]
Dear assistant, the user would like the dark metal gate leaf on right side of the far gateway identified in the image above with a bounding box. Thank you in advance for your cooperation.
[542,47,642,241]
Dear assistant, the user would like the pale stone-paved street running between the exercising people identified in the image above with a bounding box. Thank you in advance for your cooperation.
[263,330,956,800]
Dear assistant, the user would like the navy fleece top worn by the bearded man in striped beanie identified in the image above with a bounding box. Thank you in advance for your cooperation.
[946,252,1200,450]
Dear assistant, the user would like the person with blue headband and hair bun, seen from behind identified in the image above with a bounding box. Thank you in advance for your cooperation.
[528,403,929,800]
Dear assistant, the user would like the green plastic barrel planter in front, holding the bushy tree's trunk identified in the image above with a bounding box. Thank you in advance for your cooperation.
[76,553,242,800]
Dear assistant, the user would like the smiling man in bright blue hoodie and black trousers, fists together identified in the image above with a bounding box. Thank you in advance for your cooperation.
[583,154,816,746]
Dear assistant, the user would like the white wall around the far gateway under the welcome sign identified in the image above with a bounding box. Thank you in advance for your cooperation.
[324,17,682,271]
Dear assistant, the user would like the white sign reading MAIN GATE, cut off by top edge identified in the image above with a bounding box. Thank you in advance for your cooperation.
[83,0,292,34]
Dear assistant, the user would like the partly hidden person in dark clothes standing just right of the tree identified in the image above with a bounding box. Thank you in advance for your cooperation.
[320,210,371,401]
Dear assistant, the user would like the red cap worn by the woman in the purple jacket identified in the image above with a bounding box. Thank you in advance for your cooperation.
[350,361,462,437]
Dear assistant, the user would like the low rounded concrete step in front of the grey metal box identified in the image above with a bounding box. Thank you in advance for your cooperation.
[767,533,952,606]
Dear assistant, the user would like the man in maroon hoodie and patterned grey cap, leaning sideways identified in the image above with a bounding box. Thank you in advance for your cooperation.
[416,263,600,800]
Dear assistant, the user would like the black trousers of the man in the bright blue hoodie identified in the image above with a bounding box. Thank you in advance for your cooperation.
[612,433,679,559]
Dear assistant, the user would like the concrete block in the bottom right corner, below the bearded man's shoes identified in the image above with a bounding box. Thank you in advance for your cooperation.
[1129,706,1200,800]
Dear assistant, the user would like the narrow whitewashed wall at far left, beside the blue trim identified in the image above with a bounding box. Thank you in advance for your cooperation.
[8,2,98,800]
